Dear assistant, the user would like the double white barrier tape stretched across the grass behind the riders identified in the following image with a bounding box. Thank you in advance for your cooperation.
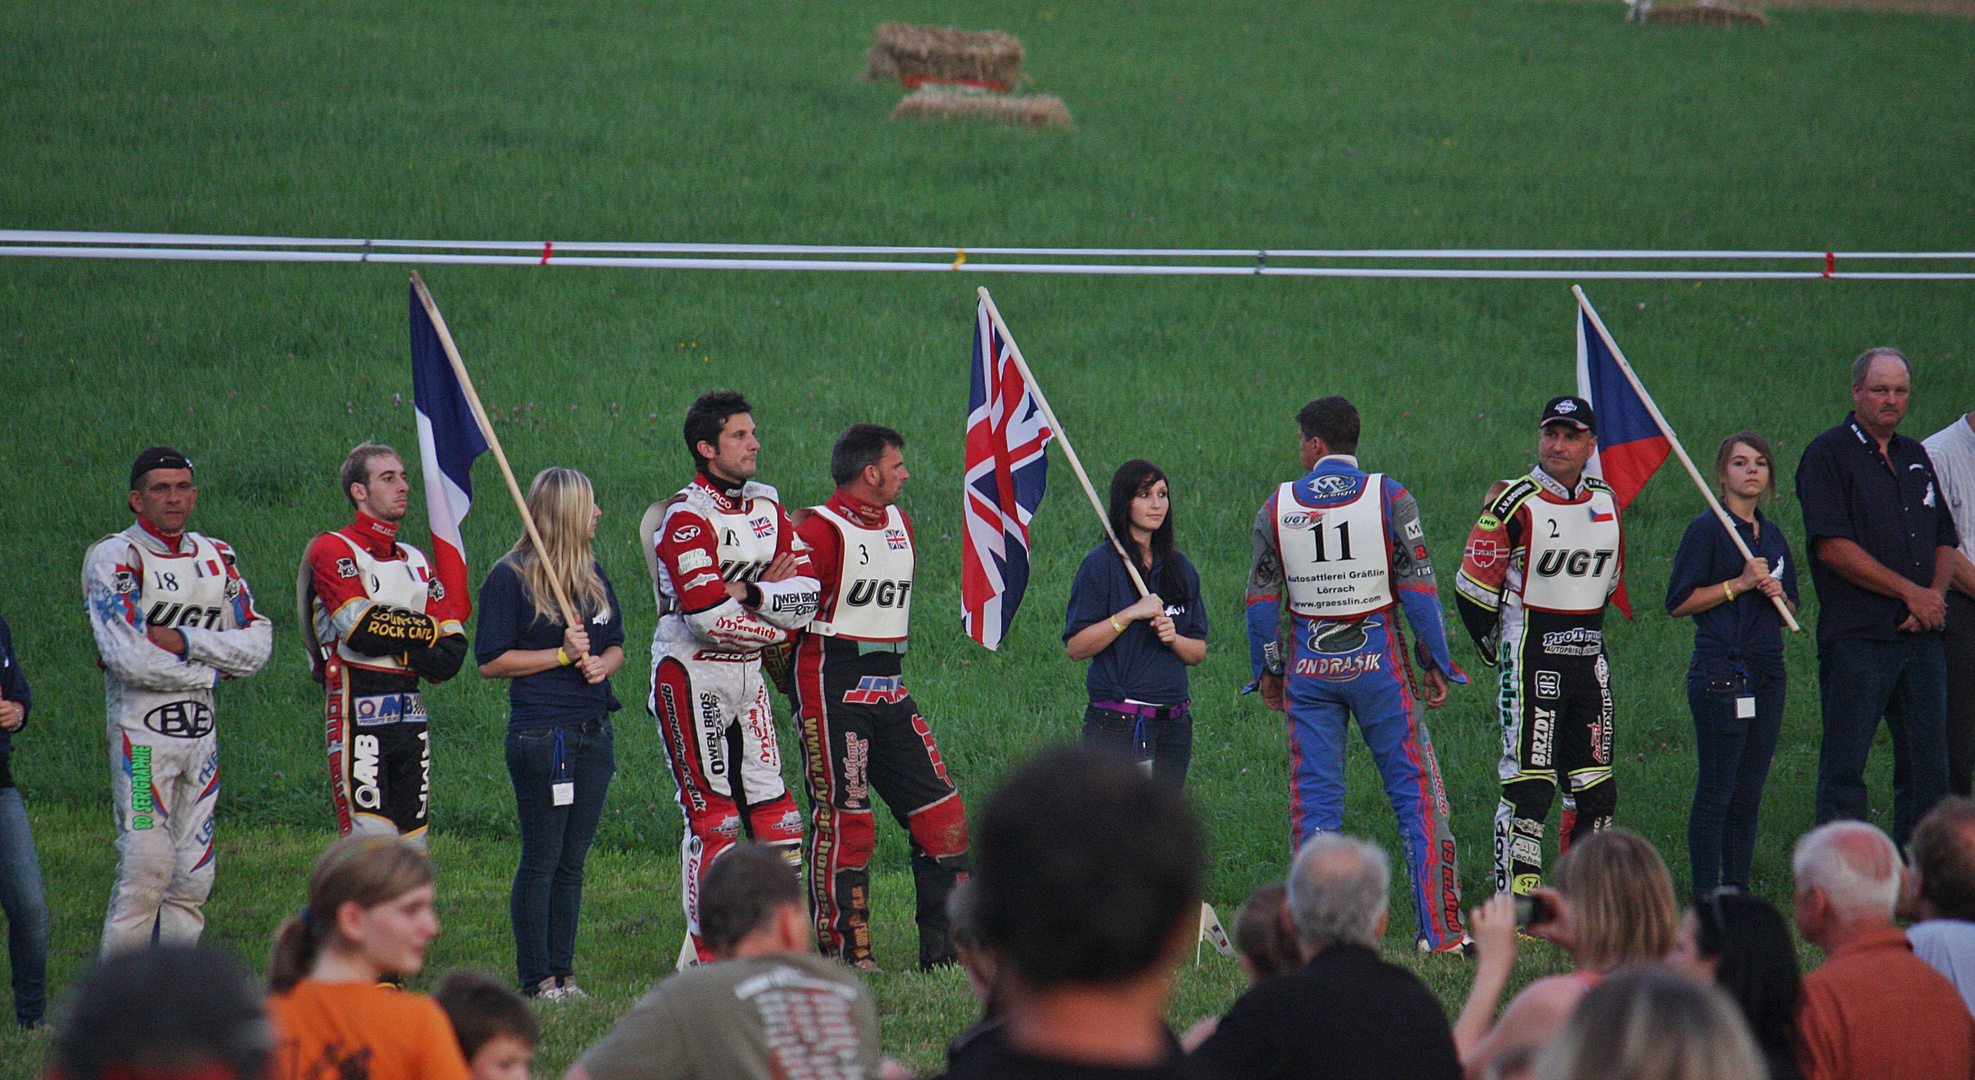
[0,229,1975,280]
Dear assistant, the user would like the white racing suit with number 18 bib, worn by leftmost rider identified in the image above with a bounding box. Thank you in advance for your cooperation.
[83,519,275,954]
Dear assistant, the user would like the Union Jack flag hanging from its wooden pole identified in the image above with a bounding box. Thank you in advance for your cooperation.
[960,300,1057,650]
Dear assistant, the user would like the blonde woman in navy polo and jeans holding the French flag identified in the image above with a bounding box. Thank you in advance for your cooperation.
[474,468,624,1001]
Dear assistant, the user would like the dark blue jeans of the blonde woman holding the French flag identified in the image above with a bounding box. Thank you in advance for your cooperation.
[508,719,616,991]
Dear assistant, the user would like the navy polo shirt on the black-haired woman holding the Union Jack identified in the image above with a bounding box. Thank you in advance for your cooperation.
[1063,543,1207,705]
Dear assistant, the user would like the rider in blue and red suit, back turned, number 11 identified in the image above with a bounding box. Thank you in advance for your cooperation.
[1248,397,1467,952]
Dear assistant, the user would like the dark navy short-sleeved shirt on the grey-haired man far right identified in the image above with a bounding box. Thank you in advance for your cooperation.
[1797,413,1957,650]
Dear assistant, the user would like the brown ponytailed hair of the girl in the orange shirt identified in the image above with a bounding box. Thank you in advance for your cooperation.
[267,835,433,993]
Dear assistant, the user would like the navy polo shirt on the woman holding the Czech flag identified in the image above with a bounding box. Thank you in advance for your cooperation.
[1667,509,1797,677]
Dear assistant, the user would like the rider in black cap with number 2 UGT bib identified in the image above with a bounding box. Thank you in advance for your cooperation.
[1454,397,1625,892]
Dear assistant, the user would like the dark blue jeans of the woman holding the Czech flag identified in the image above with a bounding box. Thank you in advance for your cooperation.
[1687,657,1785,896]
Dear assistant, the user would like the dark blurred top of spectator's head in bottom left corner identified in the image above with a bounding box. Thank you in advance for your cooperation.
[49,944,270,1080]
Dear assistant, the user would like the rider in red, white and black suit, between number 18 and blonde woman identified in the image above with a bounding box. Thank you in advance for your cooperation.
[296,442,466,849]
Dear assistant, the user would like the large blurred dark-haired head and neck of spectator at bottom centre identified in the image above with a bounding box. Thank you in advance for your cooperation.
[948,746,1203,1080]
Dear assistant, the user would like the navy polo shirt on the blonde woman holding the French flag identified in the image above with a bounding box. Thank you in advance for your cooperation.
[474,559,624,731]
